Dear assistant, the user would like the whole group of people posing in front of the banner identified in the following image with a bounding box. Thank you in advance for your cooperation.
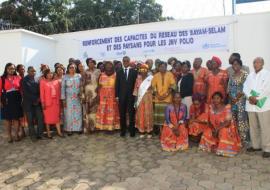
[0,53,270,157]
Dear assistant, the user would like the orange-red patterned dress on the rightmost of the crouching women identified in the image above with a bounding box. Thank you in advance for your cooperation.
[199,105,241,157]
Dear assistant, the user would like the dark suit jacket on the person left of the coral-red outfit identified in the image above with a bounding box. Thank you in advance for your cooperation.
[22,75,39,111]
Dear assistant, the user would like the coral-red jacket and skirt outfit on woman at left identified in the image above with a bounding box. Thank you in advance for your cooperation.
[40,80,61,124]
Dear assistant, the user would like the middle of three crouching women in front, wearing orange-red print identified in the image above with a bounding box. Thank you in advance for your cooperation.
[189,93,209,142]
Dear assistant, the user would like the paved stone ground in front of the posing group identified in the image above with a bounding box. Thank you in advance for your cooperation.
[0,133,270,190]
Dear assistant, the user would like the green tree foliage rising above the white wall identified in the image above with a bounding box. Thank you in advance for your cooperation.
[0,0,172,34]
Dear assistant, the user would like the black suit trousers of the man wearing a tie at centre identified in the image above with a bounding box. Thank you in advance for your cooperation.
[119,96,135,135]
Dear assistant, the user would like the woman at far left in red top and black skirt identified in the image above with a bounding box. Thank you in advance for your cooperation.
[0,63,23,143]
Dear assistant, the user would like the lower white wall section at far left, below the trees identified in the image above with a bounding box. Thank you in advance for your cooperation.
[0,30,56,75]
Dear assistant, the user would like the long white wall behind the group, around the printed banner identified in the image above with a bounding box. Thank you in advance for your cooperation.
[51,12,270,69]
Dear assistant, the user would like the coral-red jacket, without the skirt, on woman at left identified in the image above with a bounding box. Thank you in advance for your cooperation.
[40,80,61,106]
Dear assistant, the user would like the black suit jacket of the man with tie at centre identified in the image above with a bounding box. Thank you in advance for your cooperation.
[115,68,137,101]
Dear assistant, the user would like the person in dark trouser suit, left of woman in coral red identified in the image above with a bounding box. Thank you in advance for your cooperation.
[22,66,44,141]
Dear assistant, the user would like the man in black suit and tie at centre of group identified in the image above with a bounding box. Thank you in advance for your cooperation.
[115,56,137,137]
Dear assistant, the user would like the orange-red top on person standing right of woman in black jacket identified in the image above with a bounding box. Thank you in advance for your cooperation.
[192,67,208,95]
